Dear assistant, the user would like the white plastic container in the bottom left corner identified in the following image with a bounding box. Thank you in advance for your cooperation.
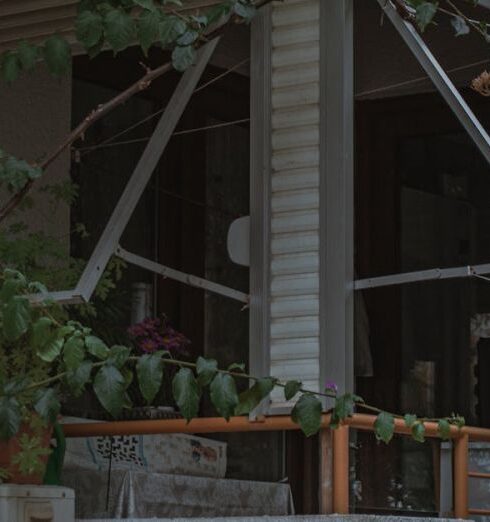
[0,484,75,522]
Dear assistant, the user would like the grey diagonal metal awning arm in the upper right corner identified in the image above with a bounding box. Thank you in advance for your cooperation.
[377,0,490,163]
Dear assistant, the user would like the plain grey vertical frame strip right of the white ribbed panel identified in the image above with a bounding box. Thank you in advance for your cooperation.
[320,0,354,393]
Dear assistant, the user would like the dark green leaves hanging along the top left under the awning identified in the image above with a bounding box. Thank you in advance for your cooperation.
[0,0,256,83]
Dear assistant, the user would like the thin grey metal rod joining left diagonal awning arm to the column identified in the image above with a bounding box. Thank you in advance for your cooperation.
[115,247,249,304]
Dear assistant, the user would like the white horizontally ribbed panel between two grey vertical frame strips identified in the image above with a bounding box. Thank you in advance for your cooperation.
[270,0,321,405]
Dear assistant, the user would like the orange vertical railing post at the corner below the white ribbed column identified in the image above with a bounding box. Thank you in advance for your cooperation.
[333,425,349,515]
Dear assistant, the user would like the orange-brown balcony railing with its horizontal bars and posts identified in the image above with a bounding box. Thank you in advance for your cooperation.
[64,414,490,518]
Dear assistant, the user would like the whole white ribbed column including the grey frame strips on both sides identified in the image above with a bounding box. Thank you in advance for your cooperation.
[251,0,353,409]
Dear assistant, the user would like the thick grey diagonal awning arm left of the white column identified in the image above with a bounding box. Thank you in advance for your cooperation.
[76,38,219,301]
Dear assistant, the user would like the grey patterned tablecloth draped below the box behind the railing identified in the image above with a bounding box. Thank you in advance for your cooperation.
[63,468,294,519]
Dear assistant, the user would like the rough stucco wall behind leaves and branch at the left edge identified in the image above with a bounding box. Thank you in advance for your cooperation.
[0,64,71,242]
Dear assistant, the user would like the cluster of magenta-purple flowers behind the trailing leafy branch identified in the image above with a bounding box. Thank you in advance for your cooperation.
[128,315,191,355]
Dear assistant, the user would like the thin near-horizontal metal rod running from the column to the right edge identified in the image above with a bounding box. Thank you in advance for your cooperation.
[354,263,490,290]
